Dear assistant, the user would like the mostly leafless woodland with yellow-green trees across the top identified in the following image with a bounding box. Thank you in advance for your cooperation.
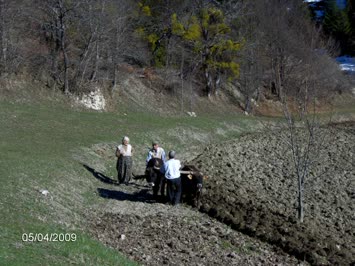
[0,0,355,110]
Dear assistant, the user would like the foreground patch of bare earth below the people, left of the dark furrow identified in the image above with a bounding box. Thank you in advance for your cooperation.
[90,180,306,265]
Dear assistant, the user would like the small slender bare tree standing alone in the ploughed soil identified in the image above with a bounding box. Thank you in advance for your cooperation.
[279,58,332,222]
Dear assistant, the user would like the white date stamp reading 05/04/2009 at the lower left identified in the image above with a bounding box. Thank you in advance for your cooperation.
[21,233,76,242]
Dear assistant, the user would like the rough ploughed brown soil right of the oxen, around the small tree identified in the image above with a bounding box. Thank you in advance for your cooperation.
[192,124,355,265]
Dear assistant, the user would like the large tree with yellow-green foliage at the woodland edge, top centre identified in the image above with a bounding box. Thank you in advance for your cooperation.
[171,7,243,96]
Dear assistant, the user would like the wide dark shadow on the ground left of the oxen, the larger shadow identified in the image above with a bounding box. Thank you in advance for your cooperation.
[97,188,157,203]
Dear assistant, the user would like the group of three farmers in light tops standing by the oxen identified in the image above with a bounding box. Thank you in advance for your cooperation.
[116,136,181,205]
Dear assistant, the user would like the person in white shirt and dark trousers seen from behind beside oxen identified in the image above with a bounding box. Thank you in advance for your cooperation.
[163,151,181,205]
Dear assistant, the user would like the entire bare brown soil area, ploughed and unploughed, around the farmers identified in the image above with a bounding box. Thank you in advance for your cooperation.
[85,121,355,265]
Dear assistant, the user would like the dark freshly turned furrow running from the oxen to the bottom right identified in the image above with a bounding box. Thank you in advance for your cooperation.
[199,180,354,265]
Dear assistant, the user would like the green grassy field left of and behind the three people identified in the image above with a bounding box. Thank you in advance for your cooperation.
[0,102,258,265]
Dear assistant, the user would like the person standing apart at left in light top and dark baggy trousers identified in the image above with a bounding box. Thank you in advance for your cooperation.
[116,136,133,185]
